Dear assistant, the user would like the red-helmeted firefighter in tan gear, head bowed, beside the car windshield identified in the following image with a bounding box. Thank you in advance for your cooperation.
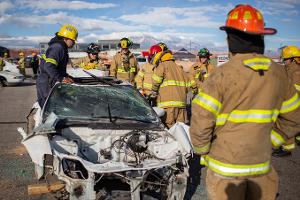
[149,45,187,128]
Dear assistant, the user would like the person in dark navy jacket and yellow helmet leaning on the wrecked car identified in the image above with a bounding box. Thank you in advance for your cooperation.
[36,24,78,108]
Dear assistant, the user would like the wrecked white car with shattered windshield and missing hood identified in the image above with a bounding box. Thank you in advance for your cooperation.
[21,78,191,199]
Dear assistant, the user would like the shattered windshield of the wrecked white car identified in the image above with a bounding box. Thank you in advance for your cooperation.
[44,84,157,123]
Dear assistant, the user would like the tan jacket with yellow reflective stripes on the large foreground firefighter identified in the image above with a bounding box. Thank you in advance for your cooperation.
[190,54,300,176]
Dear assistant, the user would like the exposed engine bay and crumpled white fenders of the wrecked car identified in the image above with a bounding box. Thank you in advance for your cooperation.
[22,113,192,170]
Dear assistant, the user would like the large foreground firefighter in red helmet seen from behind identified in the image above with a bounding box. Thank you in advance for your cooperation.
[190,4,300,200]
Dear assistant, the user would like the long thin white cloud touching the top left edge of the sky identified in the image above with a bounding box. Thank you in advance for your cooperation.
[17,0,117,10]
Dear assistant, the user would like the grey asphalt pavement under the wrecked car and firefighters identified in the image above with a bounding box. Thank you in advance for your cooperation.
[0,74,300,200]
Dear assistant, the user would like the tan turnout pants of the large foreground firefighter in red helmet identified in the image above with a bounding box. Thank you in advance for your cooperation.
[206,167,278,200]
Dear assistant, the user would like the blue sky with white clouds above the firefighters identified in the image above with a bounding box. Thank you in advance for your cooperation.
[0,0,300,51]
